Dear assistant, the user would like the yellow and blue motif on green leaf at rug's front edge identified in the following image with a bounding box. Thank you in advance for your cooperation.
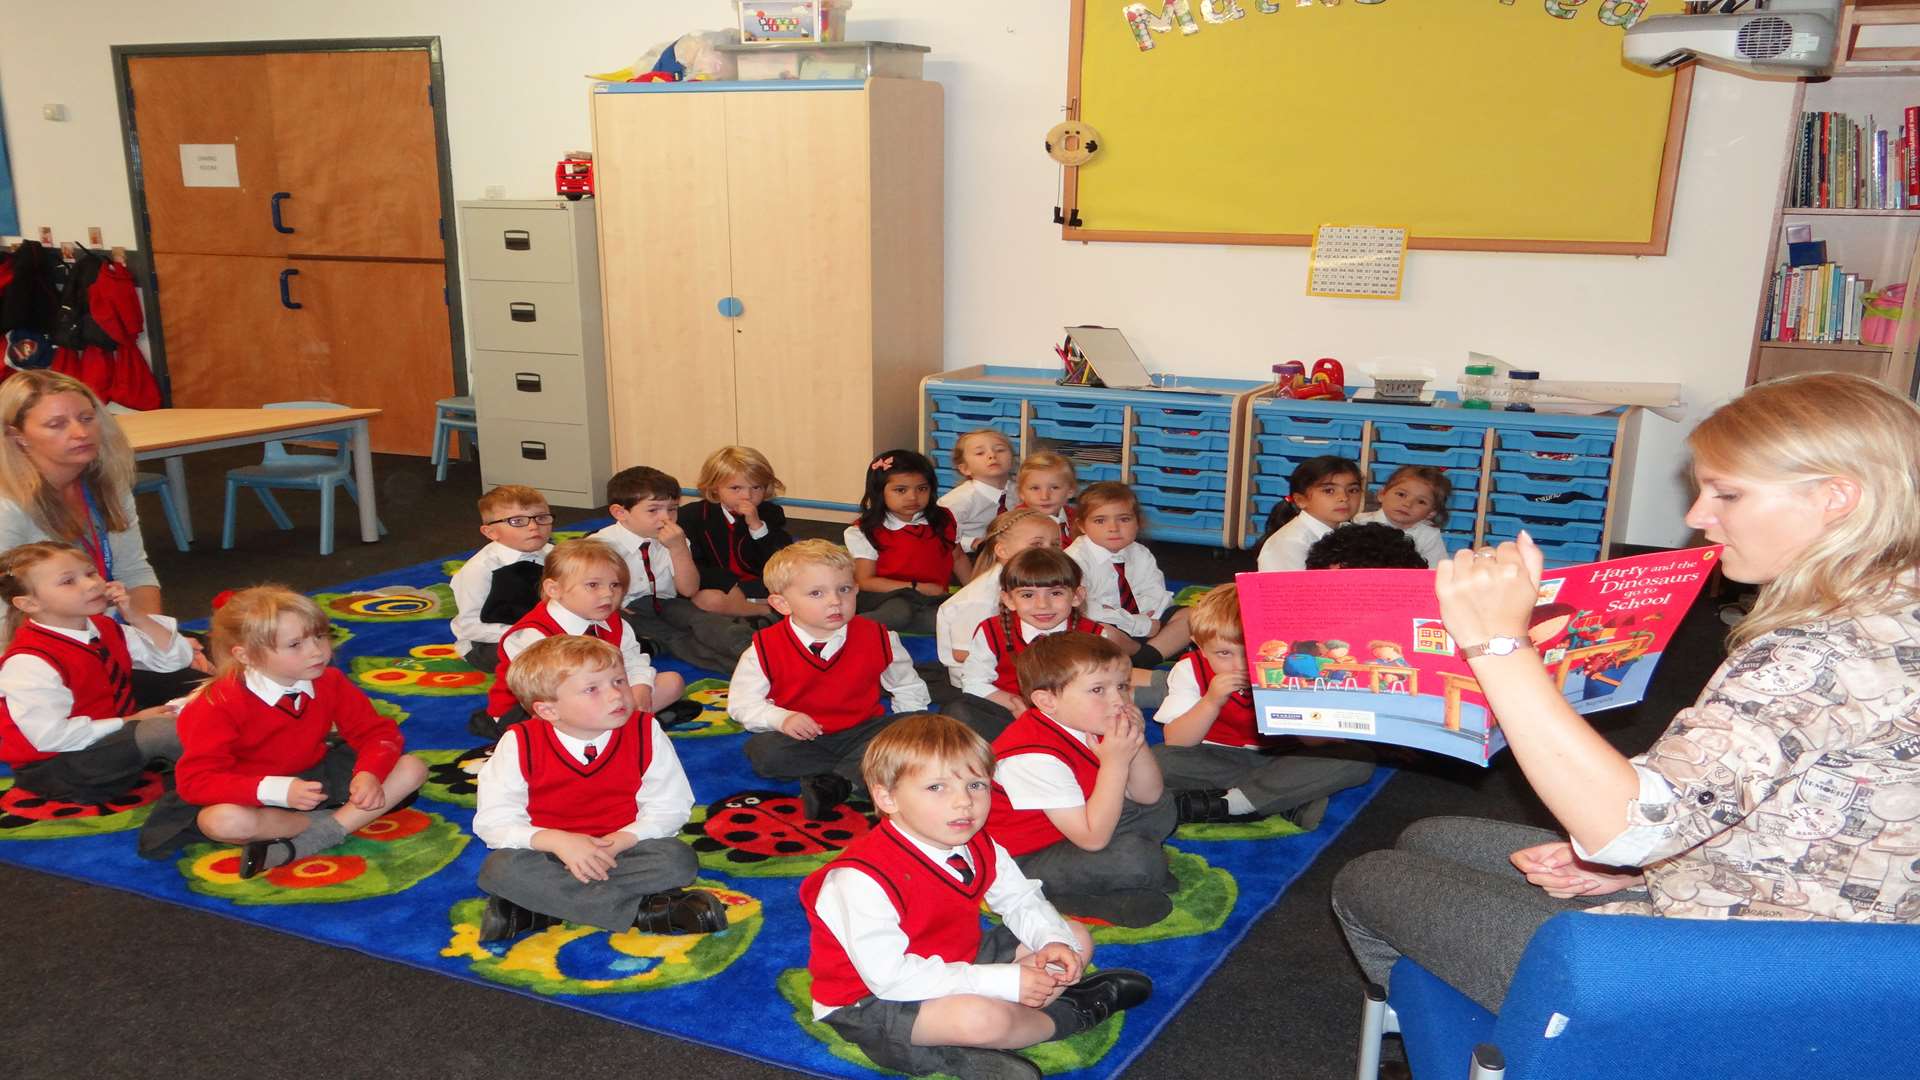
[440,878,764,995]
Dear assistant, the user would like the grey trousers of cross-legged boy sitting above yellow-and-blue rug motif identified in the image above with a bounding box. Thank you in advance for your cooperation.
[480,838,699,930]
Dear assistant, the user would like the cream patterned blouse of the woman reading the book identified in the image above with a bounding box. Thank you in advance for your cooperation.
[1592,591,1920,922]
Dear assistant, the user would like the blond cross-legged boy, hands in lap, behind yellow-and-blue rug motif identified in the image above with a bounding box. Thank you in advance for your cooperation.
[474,634,726,942]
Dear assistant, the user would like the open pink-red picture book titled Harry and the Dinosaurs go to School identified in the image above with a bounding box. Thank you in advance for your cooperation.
[1235,546,1720,765]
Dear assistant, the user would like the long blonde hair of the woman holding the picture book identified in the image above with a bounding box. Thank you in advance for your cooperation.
[1688,373,1920,648]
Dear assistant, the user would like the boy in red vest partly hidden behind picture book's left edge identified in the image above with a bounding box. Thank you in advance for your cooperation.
[1154,584,1373,828]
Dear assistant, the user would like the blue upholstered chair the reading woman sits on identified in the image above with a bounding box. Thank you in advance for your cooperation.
[1357,907,1920,1080]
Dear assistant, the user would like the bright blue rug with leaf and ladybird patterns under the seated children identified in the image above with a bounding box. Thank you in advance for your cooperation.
[0,534,1386,1080]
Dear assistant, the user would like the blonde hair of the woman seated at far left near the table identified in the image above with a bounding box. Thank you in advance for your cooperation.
[0,372,138,542]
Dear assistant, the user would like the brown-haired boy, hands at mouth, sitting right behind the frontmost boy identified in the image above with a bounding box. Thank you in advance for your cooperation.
[987,634,1177,926]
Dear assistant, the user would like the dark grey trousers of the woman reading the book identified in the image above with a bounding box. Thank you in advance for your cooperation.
[1332,817,1645,1011]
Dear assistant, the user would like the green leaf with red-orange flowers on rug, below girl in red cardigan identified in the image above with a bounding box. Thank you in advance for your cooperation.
[179,807,472,905]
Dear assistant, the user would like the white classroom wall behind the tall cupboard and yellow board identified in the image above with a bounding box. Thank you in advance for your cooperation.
[0,0,1793,544]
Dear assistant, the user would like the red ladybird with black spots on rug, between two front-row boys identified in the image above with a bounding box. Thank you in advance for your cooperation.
[680,790,877,878]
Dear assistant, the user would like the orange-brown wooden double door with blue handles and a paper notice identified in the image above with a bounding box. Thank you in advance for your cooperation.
[127,48,455,455]
